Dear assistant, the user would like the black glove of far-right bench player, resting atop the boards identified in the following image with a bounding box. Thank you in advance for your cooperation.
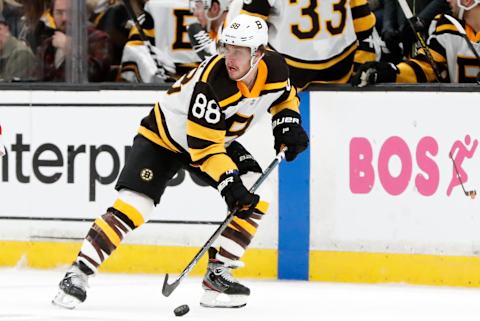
[351,61,398,87]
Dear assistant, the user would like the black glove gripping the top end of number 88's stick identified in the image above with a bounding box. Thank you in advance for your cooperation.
[272,109,308,162]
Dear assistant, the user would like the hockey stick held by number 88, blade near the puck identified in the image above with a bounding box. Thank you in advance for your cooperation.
[162,147,287,296]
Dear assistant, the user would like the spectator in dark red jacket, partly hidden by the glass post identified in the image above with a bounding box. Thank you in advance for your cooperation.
[37,0,112,82]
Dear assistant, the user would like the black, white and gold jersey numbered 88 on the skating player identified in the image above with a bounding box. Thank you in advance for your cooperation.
[139,51,299,181]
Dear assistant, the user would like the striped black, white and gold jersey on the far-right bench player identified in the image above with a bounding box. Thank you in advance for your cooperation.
[397,15,480,83]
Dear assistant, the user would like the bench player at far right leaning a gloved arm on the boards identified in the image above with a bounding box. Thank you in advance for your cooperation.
[352,0,480,87]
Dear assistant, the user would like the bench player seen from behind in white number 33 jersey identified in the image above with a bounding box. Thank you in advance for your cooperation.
[242,0,375,89]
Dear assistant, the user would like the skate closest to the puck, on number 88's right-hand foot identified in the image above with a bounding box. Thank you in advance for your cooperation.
[200,248,250,308]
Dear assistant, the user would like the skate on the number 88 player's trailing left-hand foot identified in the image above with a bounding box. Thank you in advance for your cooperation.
[52,264,88,309]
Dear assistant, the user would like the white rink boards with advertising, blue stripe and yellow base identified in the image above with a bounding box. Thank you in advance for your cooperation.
[0,91,480,286]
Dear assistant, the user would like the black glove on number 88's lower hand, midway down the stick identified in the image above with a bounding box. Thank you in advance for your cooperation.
[217,171,260,219]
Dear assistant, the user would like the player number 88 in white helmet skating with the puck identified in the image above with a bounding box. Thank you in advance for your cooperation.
[53,15,308,308]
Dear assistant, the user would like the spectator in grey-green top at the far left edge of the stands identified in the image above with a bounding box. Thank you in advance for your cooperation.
[0,14,35,81]
